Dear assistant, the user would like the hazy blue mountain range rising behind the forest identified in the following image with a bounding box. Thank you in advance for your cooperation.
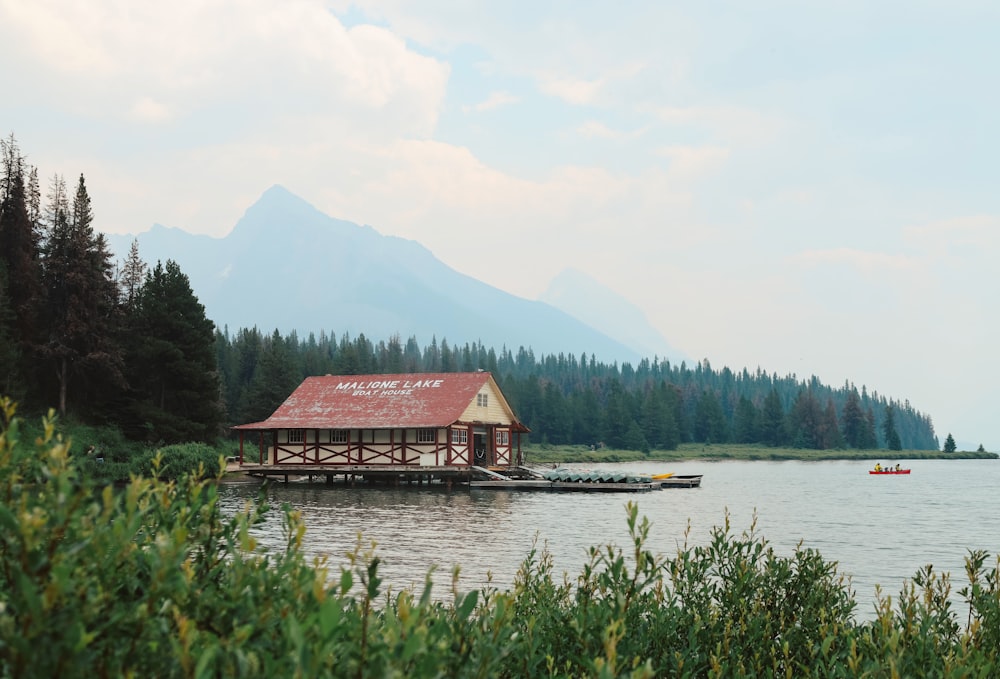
[108,186,683,363]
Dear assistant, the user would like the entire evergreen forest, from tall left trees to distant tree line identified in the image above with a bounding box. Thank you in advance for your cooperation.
[0,135,939,451]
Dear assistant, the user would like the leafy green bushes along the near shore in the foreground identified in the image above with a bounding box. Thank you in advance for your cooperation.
[0,402,1000,677]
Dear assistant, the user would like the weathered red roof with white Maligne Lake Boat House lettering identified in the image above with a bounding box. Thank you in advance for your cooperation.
[233,372,522,429]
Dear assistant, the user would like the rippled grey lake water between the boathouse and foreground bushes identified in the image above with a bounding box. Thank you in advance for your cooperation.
[221,459,1000,618]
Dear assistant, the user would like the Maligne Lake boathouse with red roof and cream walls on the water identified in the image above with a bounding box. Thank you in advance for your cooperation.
[233,372,528,480]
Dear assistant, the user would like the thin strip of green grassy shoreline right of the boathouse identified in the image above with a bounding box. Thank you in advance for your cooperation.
[524,443,1000,465]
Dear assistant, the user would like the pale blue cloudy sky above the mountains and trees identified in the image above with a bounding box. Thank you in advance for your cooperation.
[0,0,1000,451]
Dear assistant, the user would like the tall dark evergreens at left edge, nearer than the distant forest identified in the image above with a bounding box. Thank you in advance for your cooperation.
[0,136,222,443]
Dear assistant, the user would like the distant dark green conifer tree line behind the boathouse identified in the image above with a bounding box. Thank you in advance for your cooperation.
[215,328,937,450]
